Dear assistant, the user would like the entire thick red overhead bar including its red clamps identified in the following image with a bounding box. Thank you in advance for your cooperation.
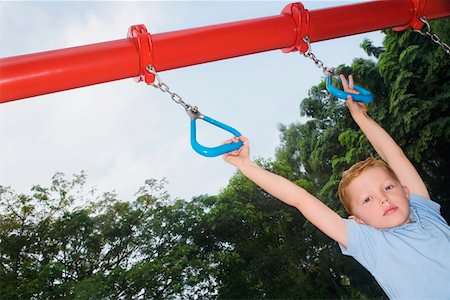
[0,0,450,103]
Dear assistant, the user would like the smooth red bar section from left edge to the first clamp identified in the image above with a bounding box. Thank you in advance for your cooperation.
[0,39,139,103]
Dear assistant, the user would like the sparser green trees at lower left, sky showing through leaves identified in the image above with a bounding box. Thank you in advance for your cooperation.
[0,173,214,299]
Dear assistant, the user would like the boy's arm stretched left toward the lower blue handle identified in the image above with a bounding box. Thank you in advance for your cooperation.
[223,137,348,247]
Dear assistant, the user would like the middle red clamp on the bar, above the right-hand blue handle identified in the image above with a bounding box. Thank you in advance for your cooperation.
[281,2,309,53]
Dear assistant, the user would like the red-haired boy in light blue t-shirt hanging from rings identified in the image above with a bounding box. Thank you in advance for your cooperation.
[223,75,450,299]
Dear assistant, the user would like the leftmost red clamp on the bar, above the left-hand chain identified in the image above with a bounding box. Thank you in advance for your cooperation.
[127,24,155,84]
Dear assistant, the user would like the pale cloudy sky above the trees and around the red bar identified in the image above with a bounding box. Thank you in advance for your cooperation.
[0,1,383,200]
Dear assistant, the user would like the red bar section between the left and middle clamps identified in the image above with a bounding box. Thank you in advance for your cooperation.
[152,15,295,71]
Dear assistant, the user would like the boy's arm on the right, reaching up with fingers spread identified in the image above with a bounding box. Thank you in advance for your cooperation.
[341,75,430,199]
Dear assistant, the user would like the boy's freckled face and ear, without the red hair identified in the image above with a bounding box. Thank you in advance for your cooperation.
[347,167,409,229]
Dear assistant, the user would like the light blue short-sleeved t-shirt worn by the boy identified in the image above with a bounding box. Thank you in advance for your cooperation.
[339,195,450,300]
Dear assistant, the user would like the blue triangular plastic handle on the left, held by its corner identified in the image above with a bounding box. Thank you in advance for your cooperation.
[191,116,243,157]
